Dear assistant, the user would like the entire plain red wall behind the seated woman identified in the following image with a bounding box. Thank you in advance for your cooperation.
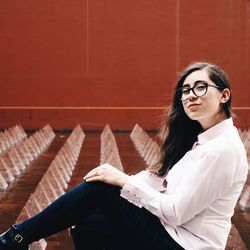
[0,0,250,129]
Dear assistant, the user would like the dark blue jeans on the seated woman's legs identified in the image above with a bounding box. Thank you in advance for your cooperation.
[16,182,183,250]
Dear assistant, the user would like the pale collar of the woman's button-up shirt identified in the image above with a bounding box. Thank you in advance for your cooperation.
[198,118,234,144]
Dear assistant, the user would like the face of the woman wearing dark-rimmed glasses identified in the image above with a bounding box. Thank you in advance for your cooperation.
[182,70,230,130]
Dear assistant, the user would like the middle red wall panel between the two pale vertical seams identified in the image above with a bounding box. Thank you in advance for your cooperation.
[89,0,176,107]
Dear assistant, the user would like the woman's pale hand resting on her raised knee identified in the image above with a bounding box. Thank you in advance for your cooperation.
[83,163,129,187]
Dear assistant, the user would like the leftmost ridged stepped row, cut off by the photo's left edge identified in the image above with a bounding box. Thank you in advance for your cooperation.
[0,125,27,155]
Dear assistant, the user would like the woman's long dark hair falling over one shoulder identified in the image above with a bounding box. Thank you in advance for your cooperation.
[149,62,232,176]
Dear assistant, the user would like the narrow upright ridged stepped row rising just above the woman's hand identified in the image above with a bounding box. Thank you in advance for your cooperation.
[100,124,123,171]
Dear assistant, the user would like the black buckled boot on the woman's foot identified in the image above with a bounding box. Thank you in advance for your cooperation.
[0,226,29,250]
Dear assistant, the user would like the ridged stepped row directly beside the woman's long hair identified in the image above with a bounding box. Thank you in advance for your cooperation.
[130,124,160,167]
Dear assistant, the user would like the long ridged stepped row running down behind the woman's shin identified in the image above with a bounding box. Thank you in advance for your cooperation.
[16,125,85,250]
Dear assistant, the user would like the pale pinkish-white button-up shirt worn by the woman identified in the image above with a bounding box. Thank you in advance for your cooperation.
[121,118,248,250]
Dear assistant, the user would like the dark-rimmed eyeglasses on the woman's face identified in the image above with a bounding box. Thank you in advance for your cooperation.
[177,81,220,101]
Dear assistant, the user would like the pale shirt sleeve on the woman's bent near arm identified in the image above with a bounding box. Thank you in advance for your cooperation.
[121,147,237,226]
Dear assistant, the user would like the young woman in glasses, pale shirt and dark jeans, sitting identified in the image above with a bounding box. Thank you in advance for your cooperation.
[0,62,248,250]
